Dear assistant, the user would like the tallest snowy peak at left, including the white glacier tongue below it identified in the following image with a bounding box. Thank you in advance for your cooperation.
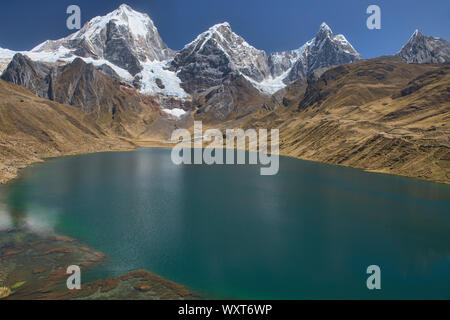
[22,4,188,98]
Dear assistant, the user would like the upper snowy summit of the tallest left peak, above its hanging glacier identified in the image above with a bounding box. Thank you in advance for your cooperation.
[31,4,173,76]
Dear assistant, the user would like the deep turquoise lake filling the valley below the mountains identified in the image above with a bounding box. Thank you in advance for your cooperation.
[0,149,450,299]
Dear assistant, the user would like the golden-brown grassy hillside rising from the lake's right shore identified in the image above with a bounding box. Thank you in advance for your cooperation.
[238,59,450,184]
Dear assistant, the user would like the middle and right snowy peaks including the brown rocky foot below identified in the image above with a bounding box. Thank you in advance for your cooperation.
[170,22,360,121]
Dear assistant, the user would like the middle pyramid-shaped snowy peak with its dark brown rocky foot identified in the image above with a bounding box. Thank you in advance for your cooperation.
[170,23,276,121]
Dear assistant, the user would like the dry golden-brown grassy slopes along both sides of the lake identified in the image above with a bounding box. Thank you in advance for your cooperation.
[0,58,450,184]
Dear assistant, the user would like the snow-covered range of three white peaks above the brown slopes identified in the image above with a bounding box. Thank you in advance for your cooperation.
[0,5,360,99]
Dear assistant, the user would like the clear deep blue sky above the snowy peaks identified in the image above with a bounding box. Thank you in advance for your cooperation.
[0,0,450,58]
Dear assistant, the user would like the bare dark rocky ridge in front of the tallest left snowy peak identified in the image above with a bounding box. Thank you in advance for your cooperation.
[2,53,190,137]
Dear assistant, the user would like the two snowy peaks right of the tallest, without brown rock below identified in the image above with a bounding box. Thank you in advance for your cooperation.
[171,22,361,94]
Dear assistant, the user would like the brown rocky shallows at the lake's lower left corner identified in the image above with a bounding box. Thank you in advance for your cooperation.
[0,227,200,300]
